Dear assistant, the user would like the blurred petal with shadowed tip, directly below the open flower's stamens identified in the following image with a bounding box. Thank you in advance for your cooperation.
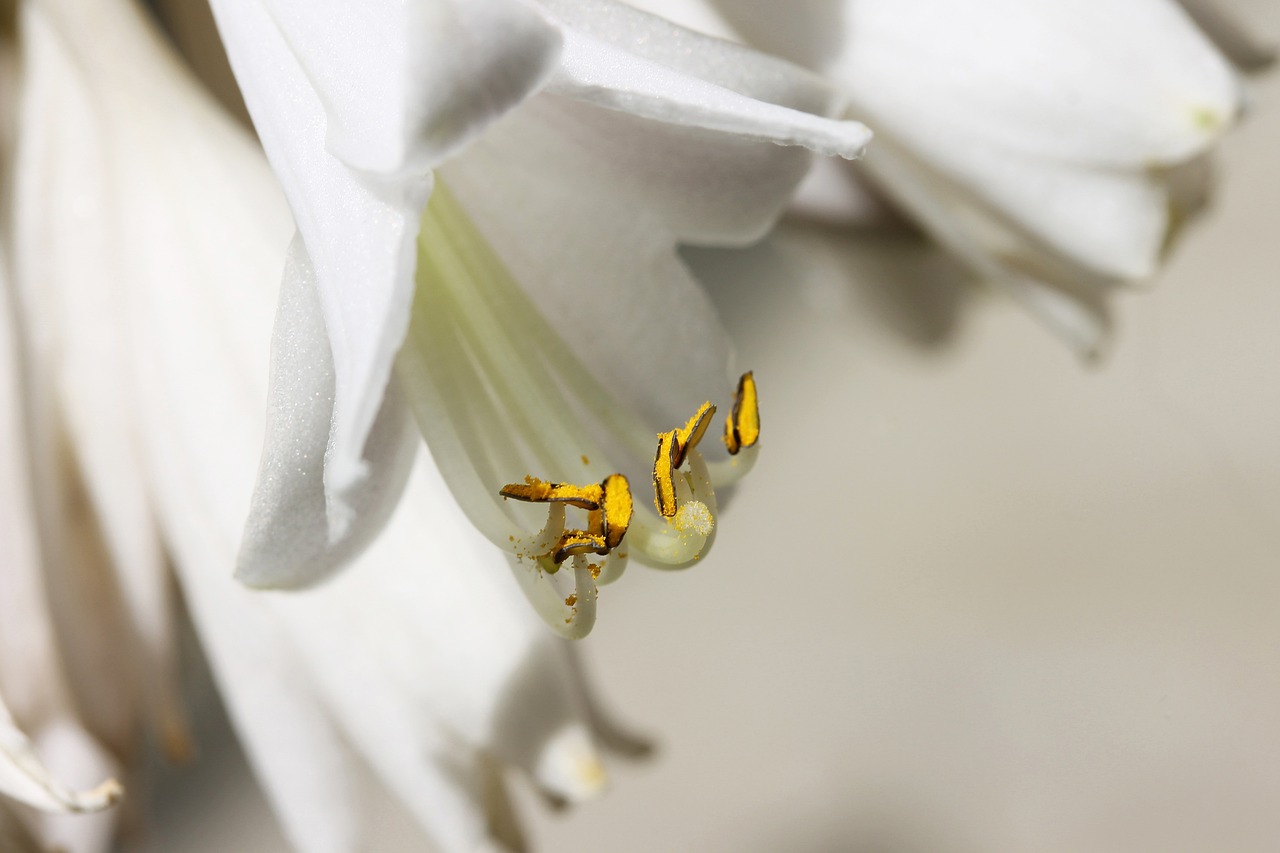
[264,456,603,824]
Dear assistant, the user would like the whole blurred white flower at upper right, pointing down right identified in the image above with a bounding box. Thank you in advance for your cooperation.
[637,0,1256,355]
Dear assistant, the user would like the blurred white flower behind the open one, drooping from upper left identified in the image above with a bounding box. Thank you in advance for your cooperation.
[12,0,860,852]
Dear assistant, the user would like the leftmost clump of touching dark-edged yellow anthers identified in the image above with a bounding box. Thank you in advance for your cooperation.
[498,474,634,566]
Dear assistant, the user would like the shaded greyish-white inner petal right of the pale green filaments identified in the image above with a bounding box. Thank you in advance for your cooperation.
[442,97,742,428]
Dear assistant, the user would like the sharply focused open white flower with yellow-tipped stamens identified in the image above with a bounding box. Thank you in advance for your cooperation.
[212,0,868,637]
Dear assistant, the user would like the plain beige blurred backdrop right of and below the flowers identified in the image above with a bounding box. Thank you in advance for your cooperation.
[148,0,1280,853]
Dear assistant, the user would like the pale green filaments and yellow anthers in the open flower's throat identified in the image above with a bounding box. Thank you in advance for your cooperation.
[397,179,759,637]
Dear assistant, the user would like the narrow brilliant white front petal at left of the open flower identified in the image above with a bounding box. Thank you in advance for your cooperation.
[212,1,430,501]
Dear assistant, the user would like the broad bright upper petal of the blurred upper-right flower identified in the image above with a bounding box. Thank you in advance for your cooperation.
[828,0,1240,169]
